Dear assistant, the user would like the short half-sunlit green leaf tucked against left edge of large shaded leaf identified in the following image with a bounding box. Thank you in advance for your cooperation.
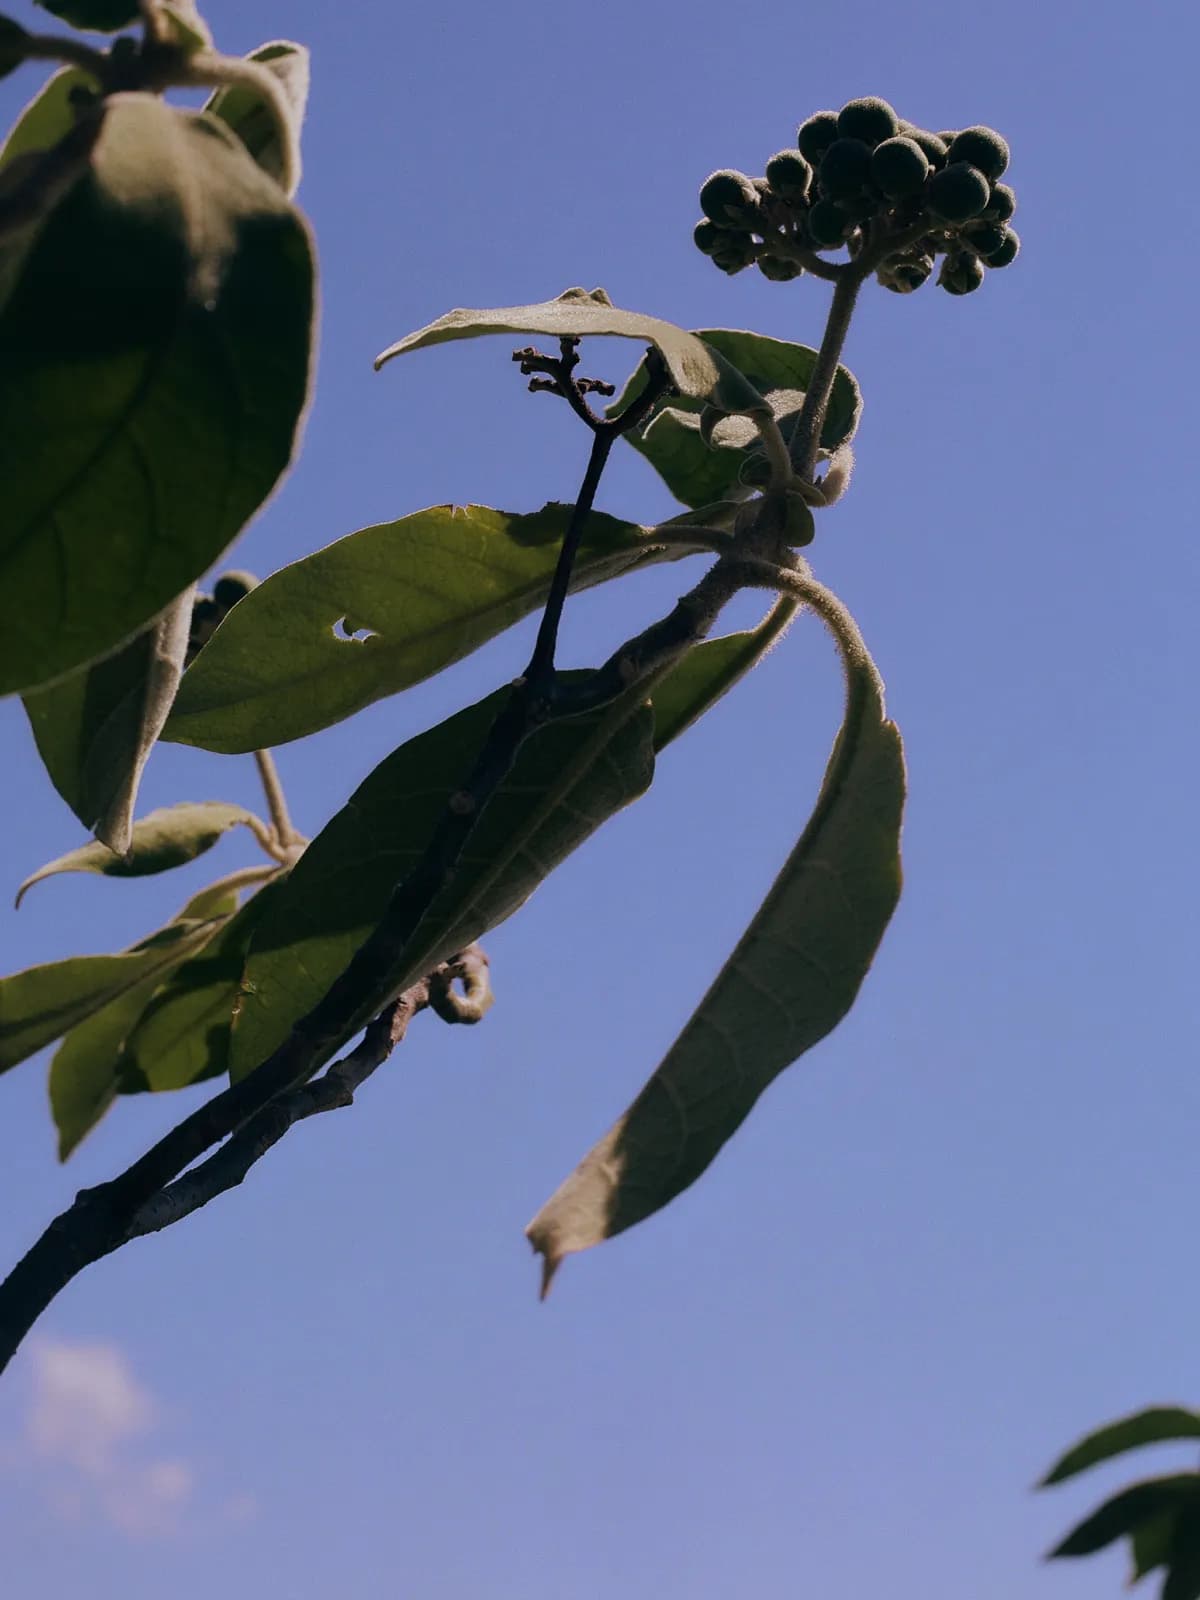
[117,878,283,1094]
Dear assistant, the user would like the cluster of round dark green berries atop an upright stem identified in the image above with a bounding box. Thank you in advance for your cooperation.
[693,98,1021,294]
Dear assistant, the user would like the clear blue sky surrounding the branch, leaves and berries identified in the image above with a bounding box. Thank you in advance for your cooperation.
[0,0,1200,1600]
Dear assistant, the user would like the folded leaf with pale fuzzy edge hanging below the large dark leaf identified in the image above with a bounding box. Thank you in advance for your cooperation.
[18,587,194,851]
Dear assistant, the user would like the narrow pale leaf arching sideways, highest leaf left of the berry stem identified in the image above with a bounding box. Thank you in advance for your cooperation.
[374,288,763,416]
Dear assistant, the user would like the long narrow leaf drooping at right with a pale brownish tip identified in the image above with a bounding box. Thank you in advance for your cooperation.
[526,624,904,1293]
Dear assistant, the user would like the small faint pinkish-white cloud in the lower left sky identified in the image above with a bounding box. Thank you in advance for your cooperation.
[8,1341,195,1538]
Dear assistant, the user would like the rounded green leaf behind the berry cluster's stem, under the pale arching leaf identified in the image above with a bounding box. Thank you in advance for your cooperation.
[608,328,862,506]
